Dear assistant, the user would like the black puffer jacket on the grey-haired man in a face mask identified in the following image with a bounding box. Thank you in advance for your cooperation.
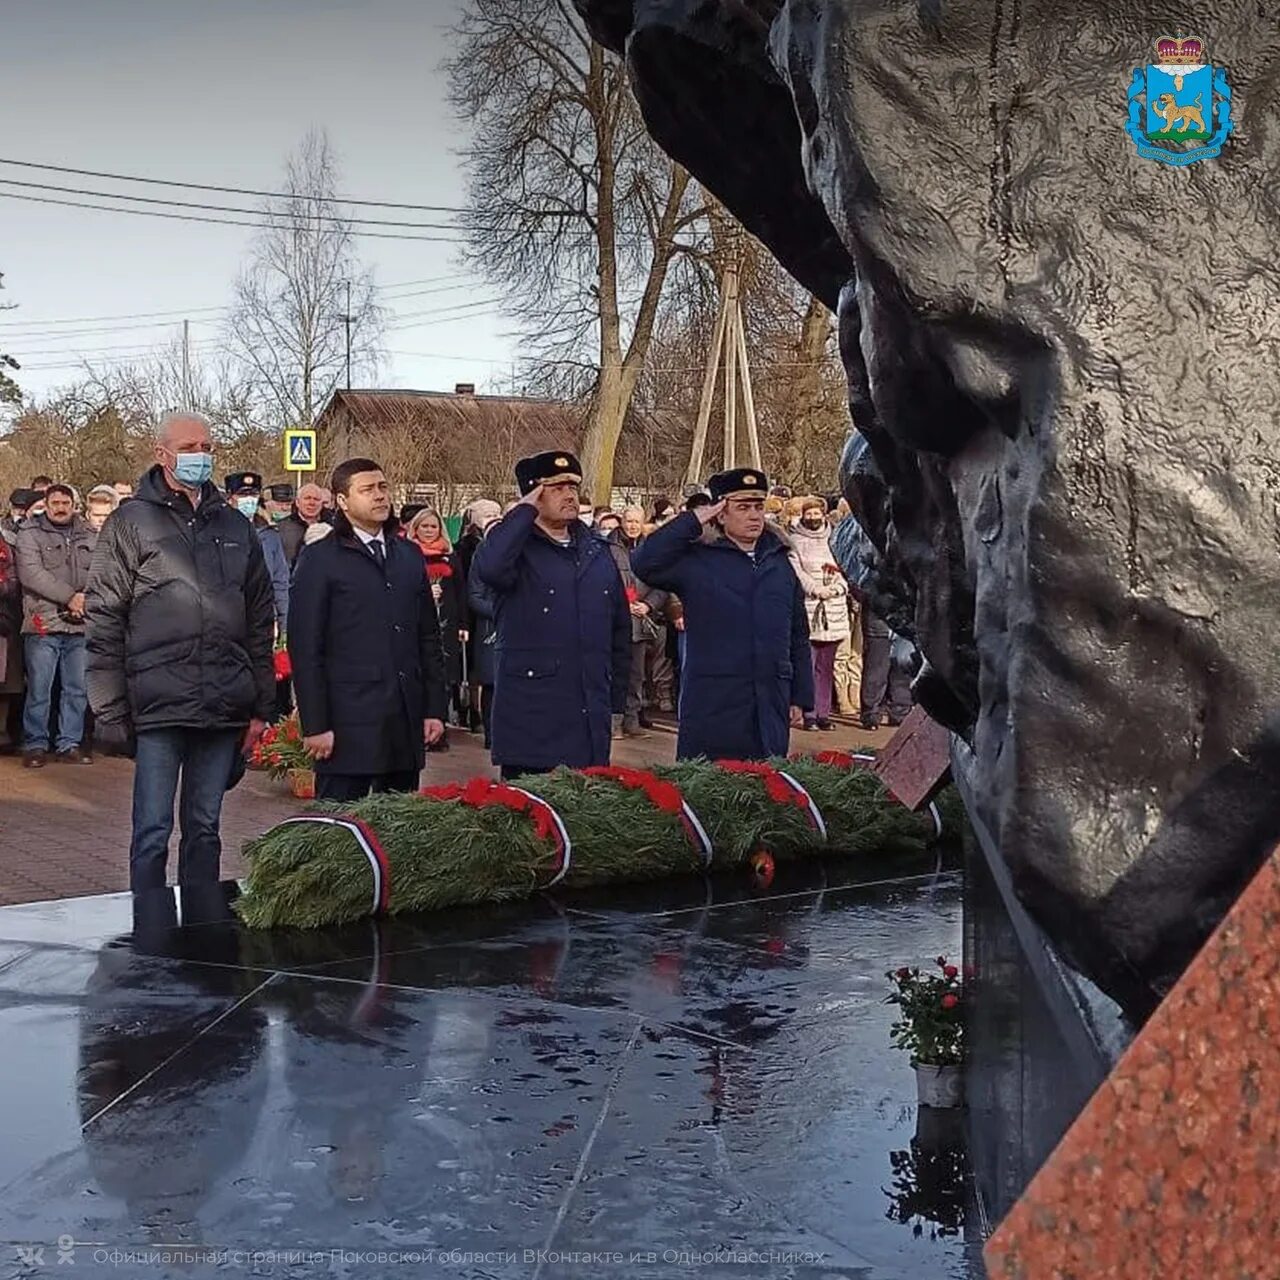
[84,466,275,730]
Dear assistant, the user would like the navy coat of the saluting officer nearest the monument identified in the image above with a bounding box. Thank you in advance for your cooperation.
[632,512,813,760]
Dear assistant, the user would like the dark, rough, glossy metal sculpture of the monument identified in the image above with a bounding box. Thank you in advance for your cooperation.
[576,0,1280,1010]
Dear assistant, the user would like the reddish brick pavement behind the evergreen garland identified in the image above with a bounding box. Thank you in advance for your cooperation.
[0,721,891,905]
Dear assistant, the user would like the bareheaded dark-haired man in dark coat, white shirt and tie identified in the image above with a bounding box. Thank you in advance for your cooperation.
[288,458,447,801]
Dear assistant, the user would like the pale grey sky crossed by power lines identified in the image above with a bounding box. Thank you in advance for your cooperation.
[0,0,516,396]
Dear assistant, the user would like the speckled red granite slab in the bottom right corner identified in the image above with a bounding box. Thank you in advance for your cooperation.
[986,851,1280,1280]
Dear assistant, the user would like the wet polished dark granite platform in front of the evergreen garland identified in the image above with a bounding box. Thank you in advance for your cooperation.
[0,858,982,1280]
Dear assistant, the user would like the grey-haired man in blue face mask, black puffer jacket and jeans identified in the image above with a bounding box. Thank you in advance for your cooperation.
[84,410,275,892]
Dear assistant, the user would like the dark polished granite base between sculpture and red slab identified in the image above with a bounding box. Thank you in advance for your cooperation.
[952,744,1132,1233]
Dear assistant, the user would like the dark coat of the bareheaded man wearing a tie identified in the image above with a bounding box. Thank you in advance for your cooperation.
[288,516,447,774]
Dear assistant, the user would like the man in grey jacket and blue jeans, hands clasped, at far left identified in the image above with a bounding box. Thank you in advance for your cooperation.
[17,484,97,769]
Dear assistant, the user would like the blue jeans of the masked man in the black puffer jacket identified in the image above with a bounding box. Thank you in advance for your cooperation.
[129,728,243,893]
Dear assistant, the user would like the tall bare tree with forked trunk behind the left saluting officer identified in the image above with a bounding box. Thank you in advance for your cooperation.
[448,0,701,498]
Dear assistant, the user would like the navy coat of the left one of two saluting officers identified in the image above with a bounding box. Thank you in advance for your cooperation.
[471,504,631,768]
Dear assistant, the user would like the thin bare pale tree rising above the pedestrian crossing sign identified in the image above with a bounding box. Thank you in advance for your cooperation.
[227,131,383,428]
